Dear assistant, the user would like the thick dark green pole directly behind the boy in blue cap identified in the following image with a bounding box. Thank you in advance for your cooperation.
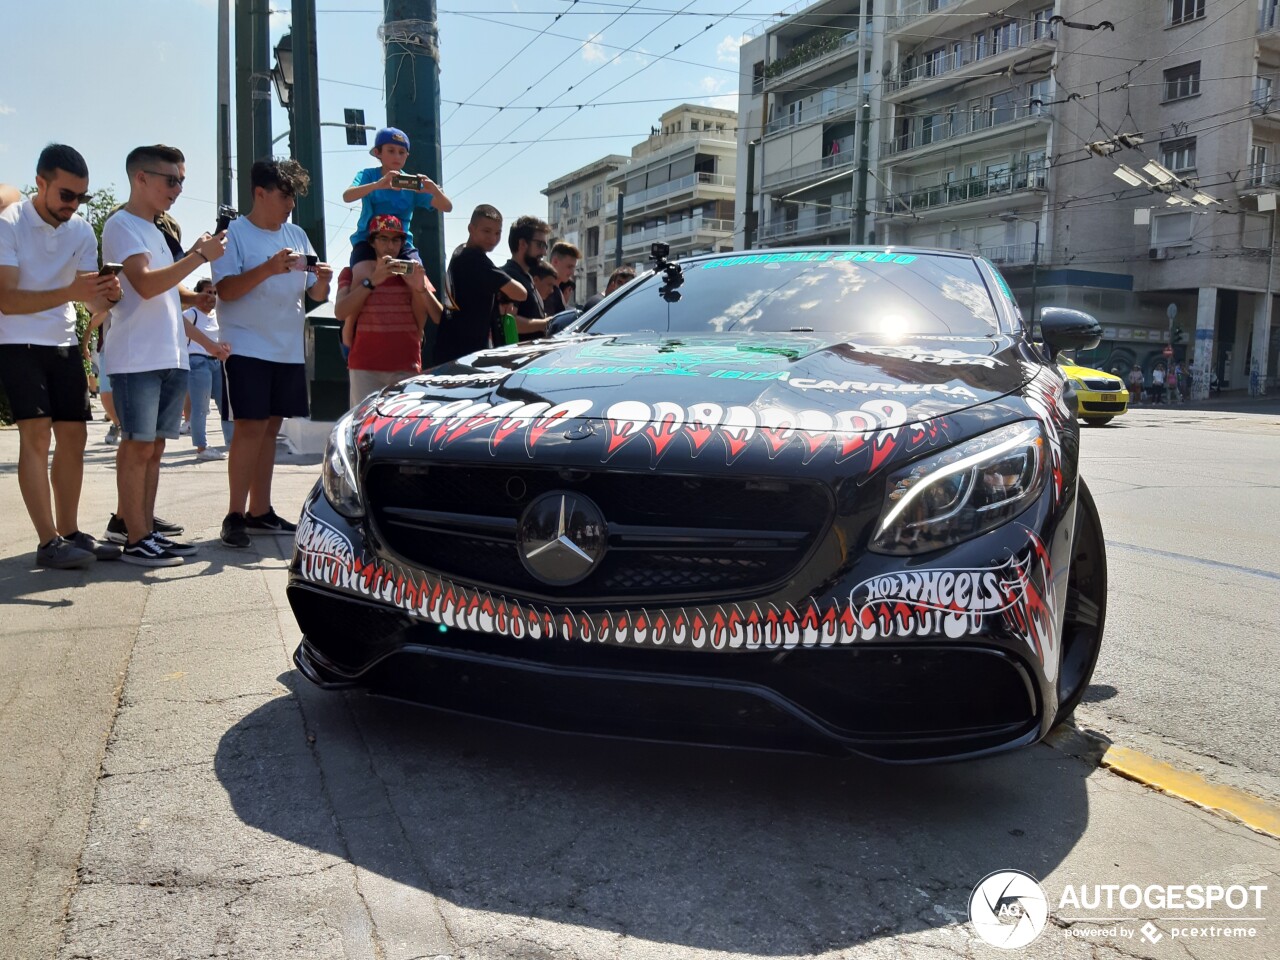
[383,0,442,293]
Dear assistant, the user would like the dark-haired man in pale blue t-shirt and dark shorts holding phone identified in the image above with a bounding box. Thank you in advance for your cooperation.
[214,160,333,547]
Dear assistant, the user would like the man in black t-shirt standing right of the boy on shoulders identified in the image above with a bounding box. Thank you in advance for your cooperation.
[434,204,529,364]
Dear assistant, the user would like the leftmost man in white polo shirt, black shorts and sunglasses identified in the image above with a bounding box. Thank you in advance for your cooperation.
[0,143,120,570]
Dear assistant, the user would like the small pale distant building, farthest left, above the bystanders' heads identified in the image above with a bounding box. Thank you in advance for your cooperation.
[540,154,627,303]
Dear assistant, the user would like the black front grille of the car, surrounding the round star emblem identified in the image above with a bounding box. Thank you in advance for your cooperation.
[365,462,832,603]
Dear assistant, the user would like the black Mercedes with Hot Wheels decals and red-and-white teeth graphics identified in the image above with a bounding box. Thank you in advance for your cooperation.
[288,247,1106,762]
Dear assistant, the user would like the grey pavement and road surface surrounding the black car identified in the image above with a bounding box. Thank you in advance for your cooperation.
[0,407,1280,960]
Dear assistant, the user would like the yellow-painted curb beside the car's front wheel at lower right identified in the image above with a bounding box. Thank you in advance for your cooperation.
[1044,724,1280,840]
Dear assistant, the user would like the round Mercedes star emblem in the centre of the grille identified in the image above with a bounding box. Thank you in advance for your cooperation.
[516,490,609,586]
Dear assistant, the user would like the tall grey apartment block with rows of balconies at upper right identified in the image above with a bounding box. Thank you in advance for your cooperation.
[739,0,1280,396]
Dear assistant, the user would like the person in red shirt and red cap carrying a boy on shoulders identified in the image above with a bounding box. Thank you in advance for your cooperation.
[334,214,440,406]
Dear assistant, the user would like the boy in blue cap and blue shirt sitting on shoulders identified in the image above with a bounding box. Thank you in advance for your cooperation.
[342,127,453,285]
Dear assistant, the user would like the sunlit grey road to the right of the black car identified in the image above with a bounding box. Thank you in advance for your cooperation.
[1078,402,1280,797]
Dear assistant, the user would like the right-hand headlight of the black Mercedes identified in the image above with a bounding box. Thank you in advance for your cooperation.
[870,420,1047,556]
